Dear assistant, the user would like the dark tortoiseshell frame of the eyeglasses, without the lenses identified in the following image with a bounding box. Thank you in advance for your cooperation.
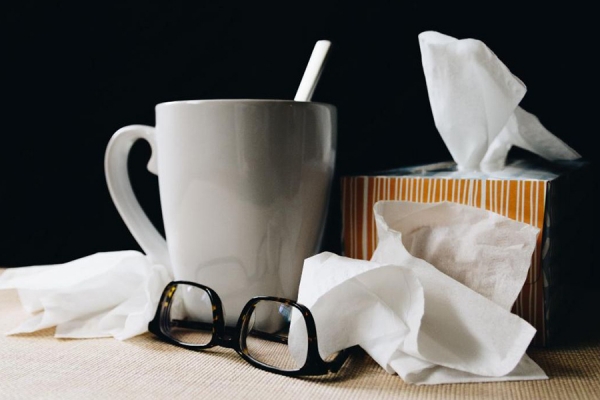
[148,281,349,376]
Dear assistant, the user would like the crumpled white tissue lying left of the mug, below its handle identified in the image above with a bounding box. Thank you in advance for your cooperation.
[0,250,172,340]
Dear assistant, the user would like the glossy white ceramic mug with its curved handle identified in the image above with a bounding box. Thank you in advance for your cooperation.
[105,99,337,325]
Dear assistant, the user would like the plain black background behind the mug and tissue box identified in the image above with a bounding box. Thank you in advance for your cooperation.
[0,1,599,267]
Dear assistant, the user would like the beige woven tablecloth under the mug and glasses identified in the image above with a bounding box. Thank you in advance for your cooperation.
[0,270,600,400]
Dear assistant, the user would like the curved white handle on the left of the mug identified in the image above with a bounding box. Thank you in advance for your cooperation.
[104,125,170,267]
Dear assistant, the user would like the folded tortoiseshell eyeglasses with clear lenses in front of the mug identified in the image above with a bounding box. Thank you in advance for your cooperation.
[148,281,349,376]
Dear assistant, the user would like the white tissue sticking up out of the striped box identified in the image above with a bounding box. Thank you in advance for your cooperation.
[419,31,581,172]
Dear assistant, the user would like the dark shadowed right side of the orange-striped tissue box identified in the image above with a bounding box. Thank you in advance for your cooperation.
[542,163,600,344]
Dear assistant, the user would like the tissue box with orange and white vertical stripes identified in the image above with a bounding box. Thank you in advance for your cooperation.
[341,159,595,346]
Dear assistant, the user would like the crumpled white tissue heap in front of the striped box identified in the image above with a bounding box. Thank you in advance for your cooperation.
[290,201,547,384]
